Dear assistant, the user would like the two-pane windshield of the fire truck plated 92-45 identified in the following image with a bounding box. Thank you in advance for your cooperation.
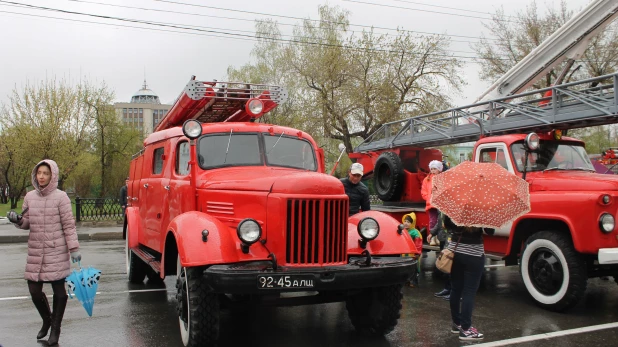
[197,132,317,171]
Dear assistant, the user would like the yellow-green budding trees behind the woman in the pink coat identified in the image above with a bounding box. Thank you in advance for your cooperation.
[0,80,142,204]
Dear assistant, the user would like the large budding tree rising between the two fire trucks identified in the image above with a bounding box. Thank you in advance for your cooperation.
[228,6,463,156]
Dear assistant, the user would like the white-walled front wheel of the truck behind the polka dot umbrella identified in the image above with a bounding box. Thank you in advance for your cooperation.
[520,231,588,312]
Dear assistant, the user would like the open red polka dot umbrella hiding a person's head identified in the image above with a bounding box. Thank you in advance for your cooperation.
[431,161,530,228]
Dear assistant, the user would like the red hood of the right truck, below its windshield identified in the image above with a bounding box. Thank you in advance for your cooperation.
[528,171,618,192]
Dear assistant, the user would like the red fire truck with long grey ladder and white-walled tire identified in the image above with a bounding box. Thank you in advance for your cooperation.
[349,0,618,311]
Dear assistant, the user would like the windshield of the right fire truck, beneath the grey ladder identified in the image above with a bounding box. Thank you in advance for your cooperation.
[511,141,594,172]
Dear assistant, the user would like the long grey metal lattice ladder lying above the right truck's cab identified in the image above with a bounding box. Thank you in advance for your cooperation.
[354,73,618,152]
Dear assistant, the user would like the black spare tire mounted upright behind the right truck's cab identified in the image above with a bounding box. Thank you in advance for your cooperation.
[373,152,404,201]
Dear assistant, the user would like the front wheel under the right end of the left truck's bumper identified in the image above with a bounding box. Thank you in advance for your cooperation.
[346,284,403,336]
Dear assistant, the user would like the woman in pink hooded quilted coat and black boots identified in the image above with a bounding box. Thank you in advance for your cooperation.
[7,159,81,346]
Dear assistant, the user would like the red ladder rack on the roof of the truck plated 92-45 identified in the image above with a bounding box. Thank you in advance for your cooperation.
[154,76,288,132]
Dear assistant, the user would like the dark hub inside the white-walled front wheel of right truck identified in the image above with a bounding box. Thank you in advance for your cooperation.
[528,248,564,295]
